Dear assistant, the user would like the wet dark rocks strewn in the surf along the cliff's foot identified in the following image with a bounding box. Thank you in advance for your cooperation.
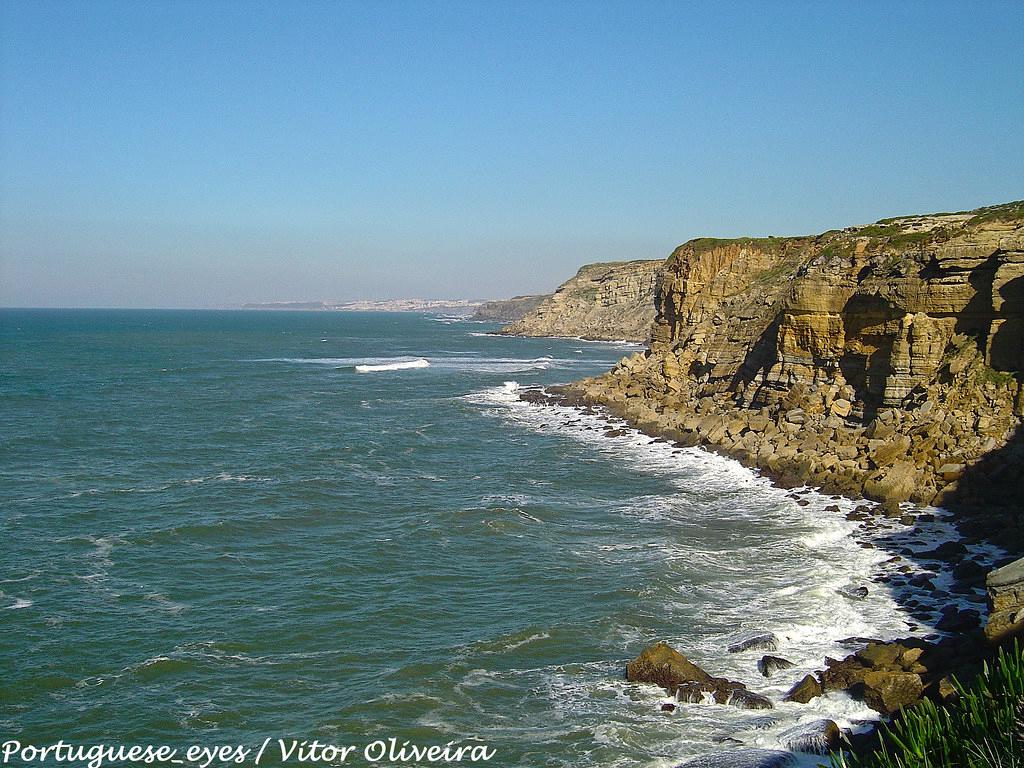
[520,386,1024,768]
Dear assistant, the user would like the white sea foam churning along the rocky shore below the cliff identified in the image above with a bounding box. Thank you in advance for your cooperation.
[464,382,1002,766]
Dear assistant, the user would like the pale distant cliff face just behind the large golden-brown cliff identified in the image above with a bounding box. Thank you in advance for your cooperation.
[502,260,664,341]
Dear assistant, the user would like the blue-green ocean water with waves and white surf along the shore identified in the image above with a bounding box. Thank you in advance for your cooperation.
[0,310,999,767]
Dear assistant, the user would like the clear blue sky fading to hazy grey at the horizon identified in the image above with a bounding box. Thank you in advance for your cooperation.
[0,0,1024,306]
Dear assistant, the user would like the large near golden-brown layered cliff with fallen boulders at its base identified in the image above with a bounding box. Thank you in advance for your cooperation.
[569,203,1024,536]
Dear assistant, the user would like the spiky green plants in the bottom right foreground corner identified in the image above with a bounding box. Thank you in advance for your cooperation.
[831,642,1024,768]
